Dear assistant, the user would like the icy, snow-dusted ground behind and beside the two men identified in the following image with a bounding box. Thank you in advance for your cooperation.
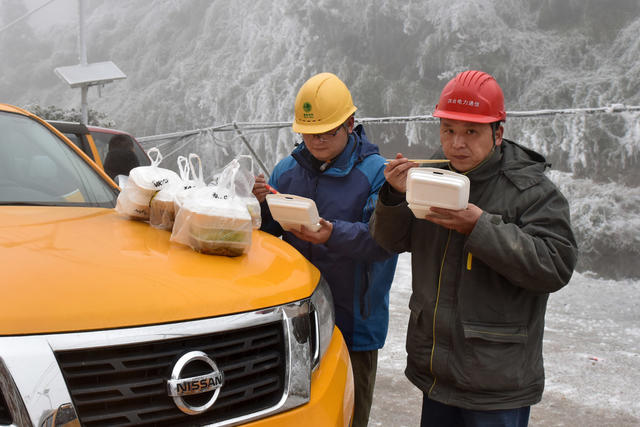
[369,254,640,427]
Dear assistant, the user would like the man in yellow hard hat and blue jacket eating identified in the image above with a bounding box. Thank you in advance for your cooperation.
[254,73,397,426]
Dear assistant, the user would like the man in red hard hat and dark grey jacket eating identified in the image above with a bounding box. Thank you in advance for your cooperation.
[370,71,577,427]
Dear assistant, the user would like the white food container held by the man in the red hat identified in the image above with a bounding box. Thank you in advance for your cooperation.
[407,168,469,218]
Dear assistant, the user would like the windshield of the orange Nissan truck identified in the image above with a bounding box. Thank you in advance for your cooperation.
[0,111,117,207]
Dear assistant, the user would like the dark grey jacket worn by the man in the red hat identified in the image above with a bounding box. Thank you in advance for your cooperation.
[370,140,577,410]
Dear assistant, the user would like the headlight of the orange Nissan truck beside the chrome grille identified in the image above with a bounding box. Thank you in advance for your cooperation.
[310,277,336,369]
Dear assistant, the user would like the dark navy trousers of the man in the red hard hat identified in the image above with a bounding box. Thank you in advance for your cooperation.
[420,394,531,427]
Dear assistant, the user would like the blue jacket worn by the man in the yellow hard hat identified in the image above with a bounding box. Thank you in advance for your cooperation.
[262,125,398,351]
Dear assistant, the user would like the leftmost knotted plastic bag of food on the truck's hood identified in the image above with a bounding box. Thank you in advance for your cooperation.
[116,147,180,221]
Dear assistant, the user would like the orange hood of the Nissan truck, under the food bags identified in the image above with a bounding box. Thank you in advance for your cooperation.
[0,206,320,335]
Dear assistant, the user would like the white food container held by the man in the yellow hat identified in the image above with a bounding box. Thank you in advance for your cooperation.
[267,193,320,231]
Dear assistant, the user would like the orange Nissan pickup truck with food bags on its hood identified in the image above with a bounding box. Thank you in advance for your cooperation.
[0,104,353,426]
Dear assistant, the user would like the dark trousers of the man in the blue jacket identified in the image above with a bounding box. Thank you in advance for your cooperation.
[349,350,378,427]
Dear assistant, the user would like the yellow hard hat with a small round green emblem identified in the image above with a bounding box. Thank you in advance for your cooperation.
[292,73,357,134]
